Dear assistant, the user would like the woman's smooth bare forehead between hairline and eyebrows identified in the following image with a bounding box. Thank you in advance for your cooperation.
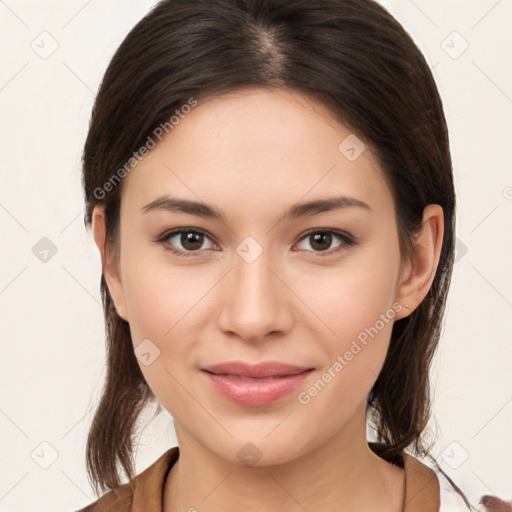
[122,88,392,222]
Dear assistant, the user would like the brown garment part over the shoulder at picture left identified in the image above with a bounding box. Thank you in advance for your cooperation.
[72,446,179,512]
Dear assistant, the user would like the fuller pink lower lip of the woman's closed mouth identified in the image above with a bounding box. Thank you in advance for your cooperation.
[202,370,312,407]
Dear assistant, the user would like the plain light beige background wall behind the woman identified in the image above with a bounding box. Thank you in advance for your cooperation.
[0,0,512,512]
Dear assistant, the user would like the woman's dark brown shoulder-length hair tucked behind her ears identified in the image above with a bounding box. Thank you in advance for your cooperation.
[82,0,467,503]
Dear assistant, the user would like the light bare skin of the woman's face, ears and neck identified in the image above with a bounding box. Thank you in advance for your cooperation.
[93,88,443,512]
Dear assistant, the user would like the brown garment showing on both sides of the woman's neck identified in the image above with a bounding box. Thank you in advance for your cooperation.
[77,442,440,512]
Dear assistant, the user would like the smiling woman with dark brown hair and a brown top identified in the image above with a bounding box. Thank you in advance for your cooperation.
[77,0,492,512]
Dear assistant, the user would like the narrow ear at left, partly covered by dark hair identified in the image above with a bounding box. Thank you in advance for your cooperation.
[92,205,127,320]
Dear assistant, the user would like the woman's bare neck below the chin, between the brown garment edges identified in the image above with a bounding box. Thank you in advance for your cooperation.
[163,404,404,512]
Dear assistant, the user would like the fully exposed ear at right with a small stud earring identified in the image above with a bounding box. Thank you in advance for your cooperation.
[395,204,444,320]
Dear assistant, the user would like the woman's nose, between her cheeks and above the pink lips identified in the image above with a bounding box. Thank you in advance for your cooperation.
[217,246,293,342]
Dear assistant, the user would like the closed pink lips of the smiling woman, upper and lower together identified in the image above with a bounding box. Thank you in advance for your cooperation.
[201,361,313,406]
